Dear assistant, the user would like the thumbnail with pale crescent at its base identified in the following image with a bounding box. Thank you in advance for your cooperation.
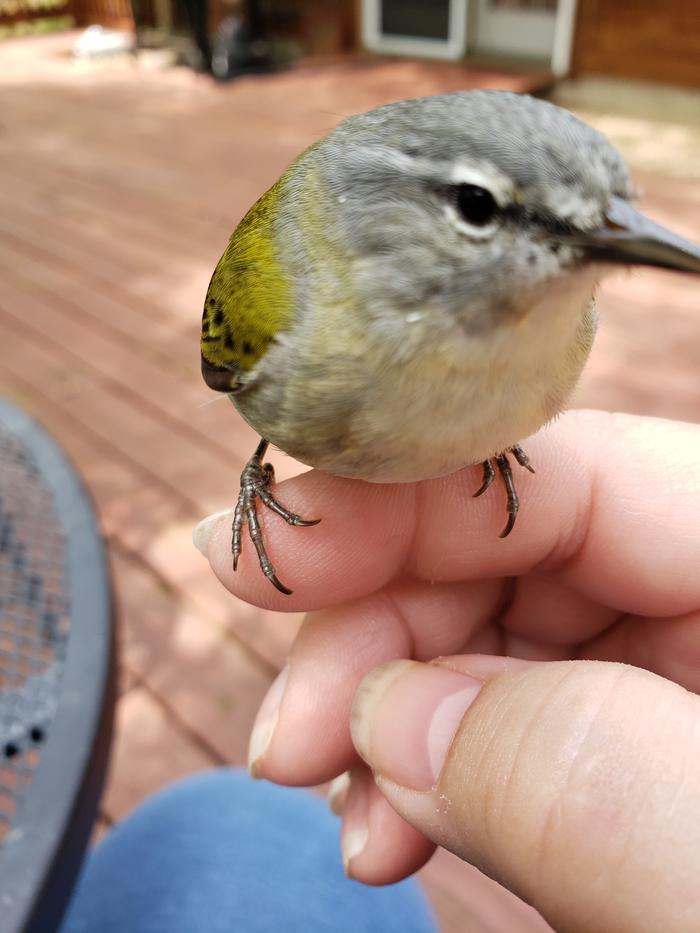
[350,661,483,791]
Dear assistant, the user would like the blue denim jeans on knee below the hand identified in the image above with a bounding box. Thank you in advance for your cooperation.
[60,769,437,933]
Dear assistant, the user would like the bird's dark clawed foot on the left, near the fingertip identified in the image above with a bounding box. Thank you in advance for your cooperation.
[231,438,321,596]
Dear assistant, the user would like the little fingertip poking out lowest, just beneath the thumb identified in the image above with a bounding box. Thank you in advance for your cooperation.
[341,766,435,884]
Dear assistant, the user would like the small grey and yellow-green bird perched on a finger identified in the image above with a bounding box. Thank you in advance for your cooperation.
[201,91,700,594]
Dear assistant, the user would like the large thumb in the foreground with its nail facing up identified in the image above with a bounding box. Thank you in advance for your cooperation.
[352,655,700,933]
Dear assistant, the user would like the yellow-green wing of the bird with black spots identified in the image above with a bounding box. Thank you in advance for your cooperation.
[201,176,293,391]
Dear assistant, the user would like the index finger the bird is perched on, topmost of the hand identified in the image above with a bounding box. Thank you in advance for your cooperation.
[197,411,700,616]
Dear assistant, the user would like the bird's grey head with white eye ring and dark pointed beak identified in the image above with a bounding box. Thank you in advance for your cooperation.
[289,91,700,331]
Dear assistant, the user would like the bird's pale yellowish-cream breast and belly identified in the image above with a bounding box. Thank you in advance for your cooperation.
[237,273,595,482]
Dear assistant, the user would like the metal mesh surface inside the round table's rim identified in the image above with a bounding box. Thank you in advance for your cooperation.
[0,433,70,843]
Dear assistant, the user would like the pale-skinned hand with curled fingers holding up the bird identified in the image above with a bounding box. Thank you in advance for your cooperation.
[194,412,700,933]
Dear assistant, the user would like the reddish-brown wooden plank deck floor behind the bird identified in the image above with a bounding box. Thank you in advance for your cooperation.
[0,36,700,931]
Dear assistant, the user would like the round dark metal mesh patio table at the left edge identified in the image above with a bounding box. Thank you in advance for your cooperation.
[0,400,115,933]
